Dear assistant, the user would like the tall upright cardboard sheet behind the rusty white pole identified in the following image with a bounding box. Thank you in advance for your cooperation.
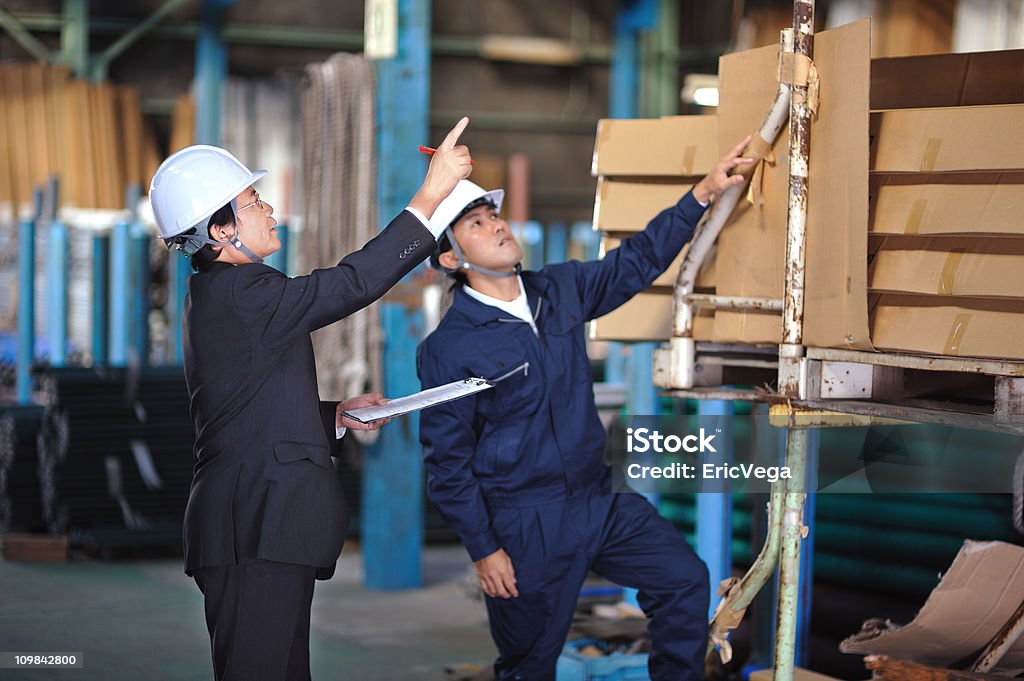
[714,19,870,346]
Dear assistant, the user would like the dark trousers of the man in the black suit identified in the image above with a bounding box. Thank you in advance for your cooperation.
[193,561,316,681]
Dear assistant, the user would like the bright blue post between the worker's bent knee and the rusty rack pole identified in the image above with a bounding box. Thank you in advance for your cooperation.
[695,399,734,619]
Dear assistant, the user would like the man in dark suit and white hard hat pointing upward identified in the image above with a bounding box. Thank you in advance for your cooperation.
[150,119,471,681]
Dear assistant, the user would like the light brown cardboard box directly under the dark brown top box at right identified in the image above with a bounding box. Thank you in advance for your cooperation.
[868,104,1024,173]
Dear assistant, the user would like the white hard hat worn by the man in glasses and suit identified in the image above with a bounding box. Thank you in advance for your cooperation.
[150,144,266,239]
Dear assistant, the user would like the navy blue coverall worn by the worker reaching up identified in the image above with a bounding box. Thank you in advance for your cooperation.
[417,188,709,681]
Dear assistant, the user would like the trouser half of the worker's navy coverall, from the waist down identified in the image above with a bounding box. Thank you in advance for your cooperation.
[486,493,710,681]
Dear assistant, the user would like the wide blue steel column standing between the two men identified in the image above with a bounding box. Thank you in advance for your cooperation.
[360,0,430,589]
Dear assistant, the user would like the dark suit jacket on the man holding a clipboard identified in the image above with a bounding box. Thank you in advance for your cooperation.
[182,211,435,579]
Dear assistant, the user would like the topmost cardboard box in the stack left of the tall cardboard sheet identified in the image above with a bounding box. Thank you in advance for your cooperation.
[591,116,720,177]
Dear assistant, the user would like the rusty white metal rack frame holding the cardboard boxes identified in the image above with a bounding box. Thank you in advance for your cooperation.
[654,0,1024,681]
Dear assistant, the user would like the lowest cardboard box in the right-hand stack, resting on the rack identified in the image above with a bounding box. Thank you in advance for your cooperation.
[871,294,1024,359]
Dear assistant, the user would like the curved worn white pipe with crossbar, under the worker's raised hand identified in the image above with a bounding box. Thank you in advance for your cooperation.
[654,29,794,389]
